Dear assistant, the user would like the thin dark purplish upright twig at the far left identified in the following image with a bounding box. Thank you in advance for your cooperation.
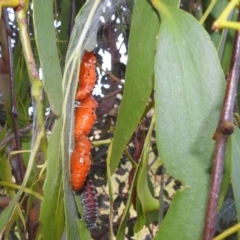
[3,8,25,184]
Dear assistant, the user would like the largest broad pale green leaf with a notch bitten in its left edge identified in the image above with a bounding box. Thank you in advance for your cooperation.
[153,0,225,240]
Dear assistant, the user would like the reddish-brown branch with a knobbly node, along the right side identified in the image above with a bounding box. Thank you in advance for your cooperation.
[203,9,240,240]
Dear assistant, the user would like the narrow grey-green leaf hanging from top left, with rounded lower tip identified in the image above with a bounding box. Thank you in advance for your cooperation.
[33,0,62,115]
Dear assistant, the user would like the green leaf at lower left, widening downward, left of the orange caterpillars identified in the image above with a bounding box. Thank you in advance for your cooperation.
[40,119,64,240]
